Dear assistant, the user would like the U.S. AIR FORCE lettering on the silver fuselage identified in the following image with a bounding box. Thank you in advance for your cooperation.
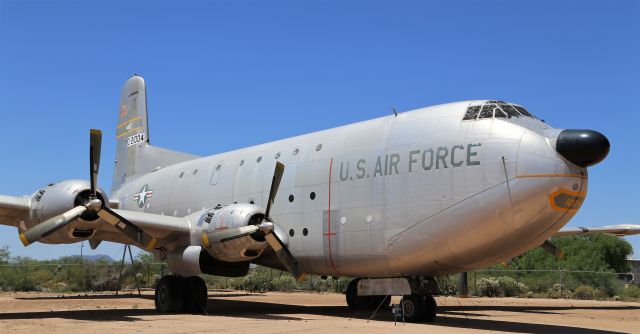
[340,143,482,181]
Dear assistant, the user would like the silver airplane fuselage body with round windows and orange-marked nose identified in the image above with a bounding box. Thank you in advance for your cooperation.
[111,101,587,277]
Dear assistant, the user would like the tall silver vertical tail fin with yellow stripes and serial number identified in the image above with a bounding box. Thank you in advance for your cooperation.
[111,75,197,191]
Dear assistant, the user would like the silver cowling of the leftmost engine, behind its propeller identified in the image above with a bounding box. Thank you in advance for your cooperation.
[26,180,109,239]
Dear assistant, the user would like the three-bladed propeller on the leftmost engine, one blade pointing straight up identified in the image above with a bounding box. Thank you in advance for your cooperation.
[20,129,156,250]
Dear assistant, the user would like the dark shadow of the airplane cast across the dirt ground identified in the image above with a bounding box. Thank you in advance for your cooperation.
[0,292,640,334]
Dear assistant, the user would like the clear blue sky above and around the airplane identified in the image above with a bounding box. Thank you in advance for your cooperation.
[0,0,640,258]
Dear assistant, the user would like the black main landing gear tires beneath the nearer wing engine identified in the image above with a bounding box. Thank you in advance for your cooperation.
[154,275,207,313]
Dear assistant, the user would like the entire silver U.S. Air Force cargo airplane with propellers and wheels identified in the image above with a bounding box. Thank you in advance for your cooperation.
[0,76,640,321]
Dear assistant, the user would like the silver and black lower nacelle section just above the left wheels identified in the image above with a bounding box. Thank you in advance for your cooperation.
[167,246,249,277]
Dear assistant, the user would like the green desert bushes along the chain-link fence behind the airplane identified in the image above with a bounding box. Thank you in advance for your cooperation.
[0,262,640,301]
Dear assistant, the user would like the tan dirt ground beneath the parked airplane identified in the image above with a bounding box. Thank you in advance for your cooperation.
[0,290,640,334]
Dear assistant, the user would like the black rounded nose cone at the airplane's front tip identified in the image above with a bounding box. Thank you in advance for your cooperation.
[556,130,610,167]
